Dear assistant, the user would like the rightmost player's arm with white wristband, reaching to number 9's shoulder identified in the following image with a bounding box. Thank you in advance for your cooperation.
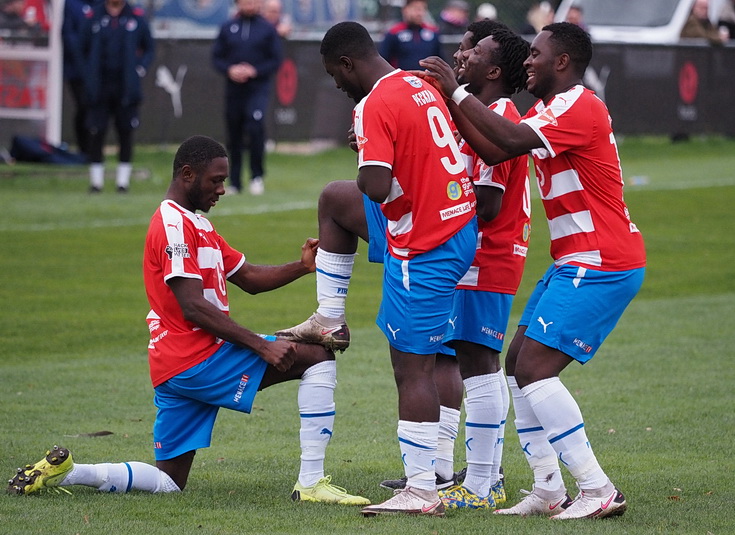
[417,56,544,157]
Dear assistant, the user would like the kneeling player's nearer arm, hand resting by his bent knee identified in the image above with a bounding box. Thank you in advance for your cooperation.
[167,277,296,371]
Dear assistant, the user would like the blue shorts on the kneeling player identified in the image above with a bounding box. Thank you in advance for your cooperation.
[153,336,275,461]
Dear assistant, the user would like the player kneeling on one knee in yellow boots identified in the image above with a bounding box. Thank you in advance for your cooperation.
[8,136,370,505]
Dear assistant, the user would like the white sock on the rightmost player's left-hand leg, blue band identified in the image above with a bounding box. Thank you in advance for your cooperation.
[508,375,564,492]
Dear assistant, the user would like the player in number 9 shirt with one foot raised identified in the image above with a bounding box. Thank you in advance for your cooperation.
[282,22,477,516]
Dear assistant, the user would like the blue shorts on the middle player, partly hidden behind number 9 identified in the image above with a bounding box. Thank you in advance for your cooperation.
[441,290,515,353]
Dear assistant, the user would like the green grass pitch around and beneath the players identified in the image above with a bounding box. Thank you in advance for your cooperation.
[0,138,735,534]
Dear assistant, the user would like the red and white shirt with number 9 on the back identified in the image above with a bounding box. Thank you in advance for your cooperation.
[353,70,476,260]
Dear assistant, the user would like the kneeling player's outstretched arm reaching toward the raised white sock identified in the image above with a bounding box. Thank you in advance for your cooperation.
[227,238,319,295]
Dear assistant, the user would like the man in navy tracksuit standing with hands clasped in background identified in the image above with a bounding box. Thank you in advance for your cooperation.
[212,0,283,195]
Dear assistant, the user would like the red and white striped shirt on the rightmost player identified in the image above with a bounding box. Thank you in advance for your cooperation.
[522,85,646,271]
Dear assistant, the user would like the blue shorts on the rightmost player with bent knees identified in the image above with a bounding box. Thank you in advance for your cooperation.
[518,265,646,364]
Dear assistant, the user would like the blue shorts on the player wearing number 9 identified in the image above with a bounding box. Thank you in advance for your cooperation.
[376,219,477,355]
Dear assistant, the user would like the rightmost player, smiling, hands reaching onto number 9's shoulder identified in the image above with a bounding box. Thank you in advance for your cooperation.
[422,23,645,520]
